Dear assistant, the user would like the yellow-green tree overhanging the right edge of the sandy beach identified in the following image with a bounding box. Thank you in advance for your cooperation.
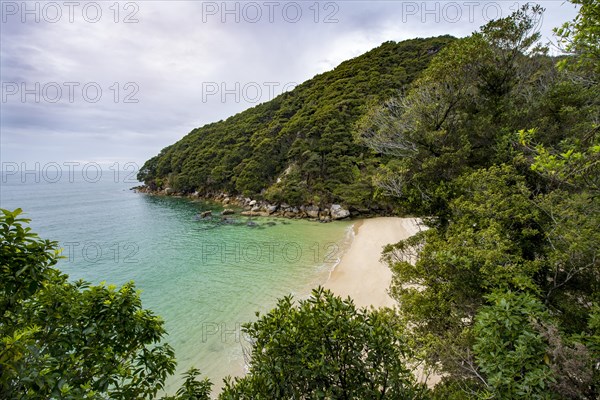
[384,166,542,377]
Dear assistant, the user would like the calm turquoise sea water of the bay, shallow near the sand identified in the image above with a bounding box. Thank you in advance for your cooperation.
[0,171,351,391]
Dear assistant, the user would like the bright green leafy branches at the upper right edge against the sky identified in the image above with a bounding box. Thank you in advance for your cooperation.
[519,0,600,195]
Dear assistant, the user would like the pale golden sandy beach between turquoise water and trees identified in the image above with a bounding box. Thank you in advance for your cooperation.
[324,217,419,307]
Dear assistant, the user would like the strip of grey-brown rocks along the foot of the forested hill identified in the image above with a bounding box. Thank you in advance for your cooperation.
[132,186,353,222]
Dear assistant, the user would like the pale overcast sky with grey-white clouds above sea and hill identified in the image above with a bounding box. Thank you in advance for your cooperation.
[0,0,576,169]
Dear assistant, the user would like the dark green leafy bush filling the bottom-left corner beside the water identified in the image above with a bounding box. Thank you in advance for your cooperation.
[0,209,210,399]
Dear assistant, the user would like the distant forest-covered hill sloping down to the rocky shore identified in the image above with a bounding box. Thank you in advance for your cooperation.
[138,36,455,209]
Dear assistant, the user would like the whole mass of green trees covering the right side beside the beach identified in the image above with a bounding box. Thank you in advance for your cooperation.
[376,1,600,399]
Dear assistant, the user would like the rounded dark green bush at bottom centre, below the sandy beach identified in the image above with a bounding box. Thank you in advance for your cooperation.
[220,288,424,399]
